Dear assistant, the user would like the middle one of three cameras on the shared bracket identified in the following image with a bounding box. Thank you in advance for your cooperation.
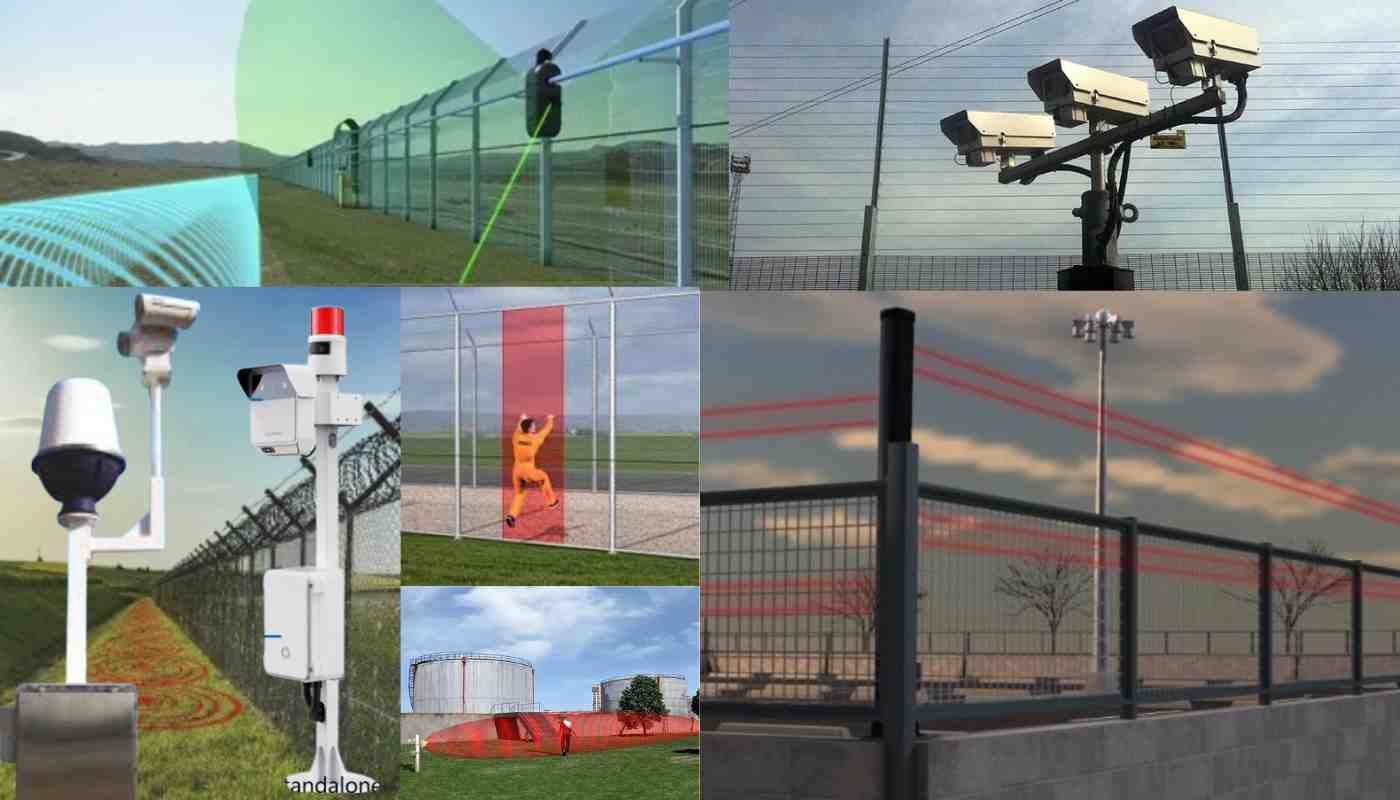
[1026,59,1148,127]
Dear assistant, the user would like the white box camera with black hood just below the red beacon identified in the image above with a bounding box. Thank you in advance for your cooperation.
[238,364,316,455]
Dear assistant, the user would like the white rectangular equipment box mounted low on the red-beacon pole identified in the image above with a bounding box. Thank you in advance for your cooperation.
[263,567,346,682]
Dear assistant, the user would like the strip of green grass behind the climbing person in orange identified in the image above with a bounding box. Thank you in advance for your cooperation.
[403,432,700,475]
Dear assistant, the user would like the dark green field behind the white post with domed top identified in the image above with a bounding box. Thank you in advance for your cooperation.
[0,562,162,688]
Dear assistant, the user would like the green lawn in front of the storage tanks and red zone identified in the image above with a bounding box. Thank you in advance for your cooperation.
[399,737,700,800]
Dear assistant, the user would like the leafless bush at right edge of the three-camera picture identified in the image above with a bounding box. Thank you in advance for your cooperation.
[1284,224,1400,291]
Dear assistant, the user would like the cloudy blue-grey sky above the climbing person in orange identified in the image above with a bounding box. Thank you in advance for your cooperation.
[402,289,700,430]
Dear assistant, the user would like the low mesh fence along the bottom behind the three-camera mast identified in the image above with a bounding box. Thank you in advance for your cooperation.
[722,251,1344,290]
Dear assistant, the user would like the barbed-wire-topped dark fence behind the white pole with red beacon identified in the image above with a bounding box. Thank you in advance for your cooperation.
[154,402,400,790]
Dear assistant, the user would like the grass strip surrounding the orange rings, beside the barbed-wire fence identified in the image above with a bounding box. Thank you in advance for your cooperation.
[0,601,315,800]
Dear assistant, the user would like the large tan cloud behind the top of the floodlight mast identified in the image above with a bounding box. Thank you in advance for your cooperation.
[704,291,1341,402]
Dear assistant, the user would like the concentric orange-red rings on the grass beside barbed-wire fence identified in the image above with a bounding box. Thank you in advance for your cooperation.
[88,598,244,731]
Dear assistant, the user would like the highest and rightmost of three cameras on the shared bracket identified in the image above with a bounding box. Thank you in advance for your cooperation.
[1133,6,1260,85]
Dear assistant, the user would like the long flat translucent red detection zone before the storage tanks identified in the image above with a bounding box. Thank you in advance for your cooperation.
[424,712,699,758]
